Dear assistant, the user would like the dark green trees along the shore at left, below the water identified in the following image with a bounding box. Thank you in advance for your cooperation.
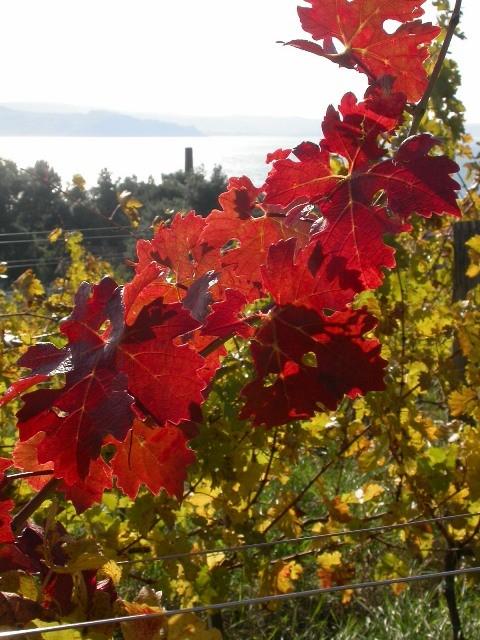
[0,161,226,284]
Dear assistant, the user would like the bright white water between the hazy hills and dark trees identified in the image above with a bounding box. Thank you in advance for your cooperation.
[0,136,303,187]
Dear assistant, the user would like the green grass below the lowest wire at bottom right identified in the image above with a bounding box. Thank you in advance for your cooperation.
[218,581,480,640]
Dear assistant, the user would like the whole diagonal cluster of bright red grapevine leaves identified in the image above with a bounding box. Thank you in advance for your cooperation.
[1,0,459,539]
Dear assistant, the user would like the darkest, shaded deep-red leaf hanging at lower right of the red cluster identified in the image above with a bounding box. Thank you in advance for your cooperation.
[241,305,386,426]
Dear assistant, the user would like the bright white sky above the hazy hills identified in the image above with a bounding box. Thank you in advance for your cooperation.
[0,0,480,122]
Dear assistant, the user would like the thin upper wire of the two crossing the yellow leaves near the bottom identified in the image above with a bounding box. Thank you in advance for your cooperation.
[118,512,480,564]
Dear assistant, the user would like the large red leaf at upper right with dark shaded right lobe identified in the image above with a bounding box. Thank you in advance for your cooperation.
[265,98,458,288]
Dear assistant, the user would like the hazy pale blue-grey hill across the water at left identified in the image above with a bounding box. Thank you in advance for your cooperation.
[0,106,202,137]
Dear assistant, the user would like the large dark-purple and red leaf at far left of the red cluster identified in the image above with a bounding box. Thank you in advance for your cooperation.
[2,266,208,488]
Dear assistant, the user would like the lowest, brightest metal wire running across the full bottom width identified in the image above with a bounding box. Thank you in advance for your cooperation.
[0,567,480,638]
